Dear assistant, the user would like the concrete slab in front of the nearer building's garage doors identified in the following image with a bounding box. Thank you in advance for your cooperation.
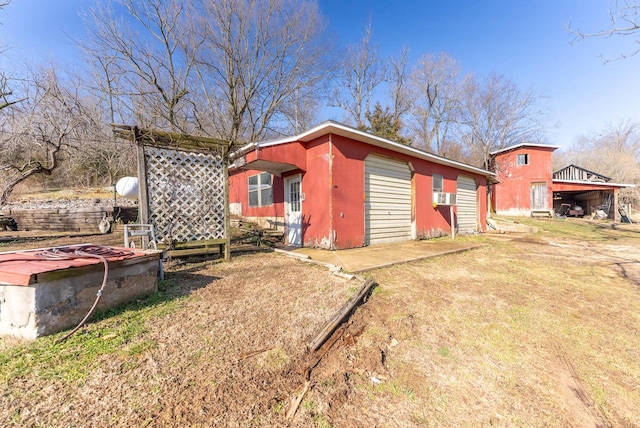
[278,240,482,273]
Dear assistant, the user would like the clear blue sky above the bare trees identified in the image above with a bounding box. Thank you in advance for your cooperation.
[0,0,640,150]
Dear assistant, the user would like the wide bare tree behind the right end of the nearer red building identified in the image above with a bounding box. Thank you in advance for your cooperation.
[459,74,545,169]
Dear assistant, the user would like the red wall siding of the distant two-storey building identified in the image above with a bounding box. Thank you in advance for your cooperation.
[492,146,554,211]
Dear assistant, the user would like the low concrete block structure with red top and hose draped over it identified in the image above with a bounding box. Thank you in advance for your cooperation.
[0,249,162,339]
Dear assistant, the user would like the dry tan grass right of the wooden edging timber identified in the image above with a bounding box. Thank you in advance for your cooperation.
[308,221,640,426]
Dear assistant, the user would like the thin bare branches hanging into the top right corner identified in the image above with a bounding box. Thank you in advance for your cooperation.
[569,0,640,58]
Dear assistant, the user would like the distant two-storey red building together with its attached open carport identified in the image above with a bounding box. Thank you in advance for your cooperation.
[490,143,633,219]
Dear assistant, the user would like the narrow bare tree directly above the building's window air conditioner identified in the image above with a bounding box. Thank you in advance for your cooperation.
[409,53,461,156]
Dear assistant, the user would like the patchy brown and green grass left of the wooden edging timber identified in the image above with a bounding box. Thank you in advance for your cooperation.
[0,253,353,426]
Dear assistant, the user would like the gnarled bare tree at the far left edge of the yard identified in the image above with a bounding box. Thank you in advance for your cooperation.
[0,67,99,205]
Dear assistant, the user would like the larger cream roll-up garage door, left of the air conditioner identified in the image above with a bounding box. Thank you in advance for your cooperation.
[364,155,411,245]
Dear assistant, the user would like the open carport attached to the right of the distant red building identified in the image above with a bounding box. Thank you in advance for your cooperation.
[551,165,633,221]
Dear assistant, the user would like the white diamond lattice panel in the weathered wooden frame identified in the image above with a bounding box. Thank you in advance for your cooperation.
[144,146,225,244]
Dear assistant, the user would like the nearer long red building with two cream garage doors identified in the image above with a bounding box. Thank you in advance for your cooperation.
[229,121,494,249]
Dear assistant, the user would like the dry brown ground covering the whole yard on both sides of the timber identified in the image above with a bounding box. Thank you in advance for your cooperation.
[0,220,640,427]
